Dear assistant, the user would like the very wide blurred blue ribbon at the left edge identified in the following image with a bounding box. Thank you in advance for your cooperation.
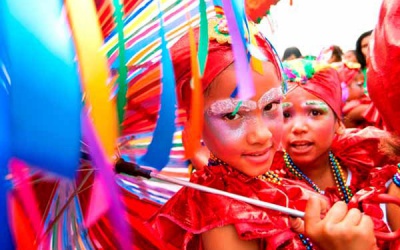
[0,0,81,178]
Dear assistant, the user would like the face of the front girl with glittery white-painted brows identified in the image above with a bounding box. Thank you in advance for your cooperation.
[203,62,283,176]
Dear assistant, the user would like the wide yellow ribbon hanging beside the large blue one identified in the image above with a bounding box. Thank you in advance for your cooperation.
[65,0,118,162]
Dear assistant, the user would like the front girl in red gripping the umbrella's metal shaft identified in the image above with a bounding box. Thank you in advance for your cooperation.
[151,15,382,249]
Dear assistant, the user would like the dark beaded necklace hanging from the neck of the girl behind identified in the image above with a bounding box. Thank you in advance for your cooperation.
[283,149,353,250]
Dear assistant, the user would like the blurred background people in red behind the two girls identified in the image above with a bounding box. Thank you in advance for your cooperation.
[282,30,378,131]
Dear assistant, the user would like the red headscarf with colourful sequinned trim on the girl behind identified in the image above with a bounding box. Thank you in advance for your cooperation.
[283,59,342,119]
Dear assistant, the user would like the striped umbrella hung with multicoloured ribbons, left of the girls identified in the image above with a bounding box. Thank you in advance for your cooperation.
[0,0,290,249]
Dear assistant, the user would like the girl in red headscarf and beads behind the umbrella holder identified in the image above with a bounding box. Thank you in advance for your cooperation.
[274,60,396,246]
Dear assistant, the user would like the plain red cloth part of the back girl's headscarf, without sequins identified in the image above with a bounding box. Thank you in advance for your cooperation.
[293,68,342,118]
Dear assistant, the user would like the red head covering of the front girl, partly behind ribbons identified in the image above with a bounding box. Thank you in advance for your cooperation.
[170,18,281,108]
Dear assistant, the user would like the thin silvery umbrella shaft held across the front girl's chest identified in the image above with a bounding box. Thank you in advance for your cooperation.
[150,172,304,218]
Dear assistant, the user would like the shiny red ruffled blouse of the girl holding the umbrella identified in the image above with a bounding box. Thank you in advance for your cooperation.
[151,161,326,249]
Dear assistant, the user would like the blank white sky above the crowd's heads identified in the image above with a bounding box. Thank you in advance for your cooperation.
[260,0,382,57]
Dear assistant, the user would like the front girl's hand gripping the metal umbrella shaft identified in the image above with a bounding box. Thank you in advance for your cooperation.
[290,197,377,250]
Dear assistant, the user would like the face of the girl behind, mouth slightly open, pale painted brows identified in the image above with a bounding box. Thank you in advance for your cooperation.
[282,87,339,166]
